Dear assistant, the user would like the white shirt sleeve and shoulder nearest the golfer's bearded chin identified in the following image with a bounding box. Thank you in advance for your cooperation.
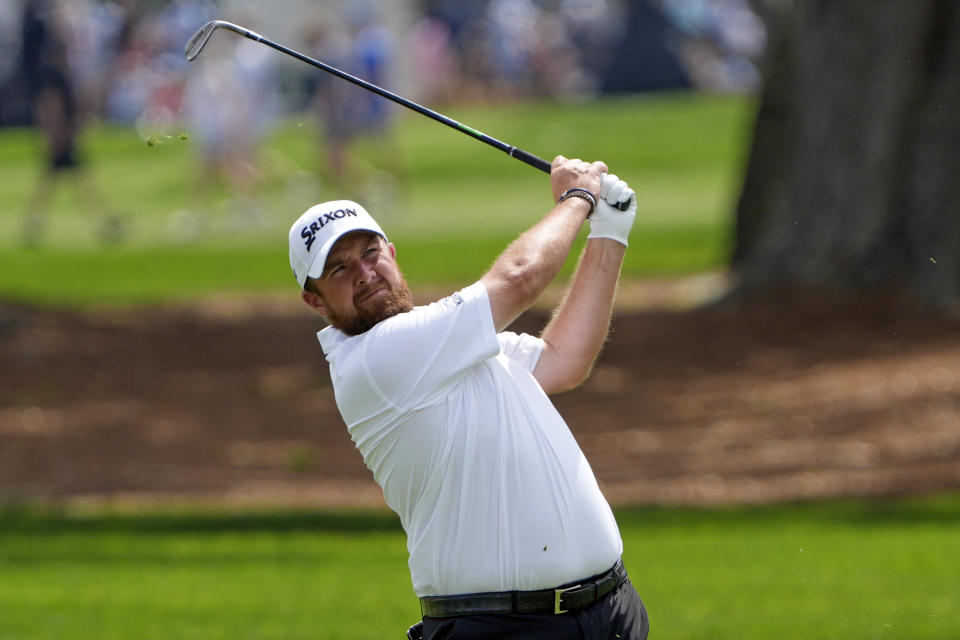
[364,282,500,409]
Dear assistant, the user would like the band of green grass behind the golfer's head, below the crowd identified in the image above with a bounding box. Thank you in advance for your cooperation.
[0,94,753,306]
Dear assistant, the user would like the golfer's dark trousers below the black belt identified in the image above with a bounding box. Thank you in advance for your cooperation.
[423,580,650,640]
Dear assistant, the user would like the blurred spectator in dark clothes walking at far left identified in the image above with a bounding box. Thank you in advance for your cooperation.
[20,0,123,245]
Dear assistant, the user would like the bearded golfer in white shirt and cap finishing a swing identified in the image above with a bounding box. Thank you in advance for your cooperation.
[289,156,648,640]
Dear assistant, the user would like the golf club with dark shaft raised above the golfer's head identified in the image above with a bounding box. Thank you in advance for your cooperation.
[184,20,628,209]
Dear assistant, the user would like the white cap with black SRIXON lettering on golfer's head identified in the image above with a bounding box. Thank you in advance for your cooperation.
[289,200,387,289]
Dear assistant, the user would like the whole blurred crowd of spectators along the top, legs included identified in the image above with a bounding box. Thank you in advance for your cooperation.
[0,0,765,240]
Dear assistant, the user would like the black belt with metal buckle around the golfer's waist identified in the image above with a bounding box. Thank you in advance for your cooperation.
[420,560,627,618]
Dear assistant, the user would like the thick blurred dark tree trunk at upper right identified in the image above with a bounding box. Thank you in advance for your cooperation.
[733,0,960,304]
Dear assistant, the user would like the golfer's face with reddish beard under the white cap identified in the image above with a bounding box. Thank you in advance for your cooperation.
[303,231,413,336]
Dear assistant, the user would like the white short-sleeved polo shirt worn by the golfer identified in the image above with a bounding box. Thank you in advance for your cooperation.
[318,282,623,597]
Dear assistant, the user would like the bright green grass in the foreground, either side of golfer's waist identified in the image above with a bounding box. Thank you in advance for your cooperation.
[0,495,960,640]
